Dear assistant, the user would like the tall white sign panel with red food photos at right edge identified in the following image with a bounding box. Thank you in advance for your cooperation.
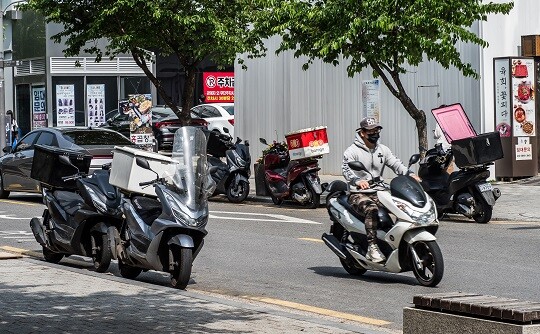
[512,58,536,137]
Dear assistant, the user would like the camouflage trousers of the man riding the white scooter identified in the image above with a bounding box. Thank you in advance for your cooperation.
[349,192,381,244]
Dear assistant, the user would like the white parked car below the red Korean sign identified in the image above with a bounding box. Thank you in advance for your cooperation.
[191,103,234,138]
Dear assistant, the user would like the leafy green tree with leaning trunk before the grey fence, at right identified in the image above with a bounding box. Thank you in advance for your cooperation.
[252,0,513,152]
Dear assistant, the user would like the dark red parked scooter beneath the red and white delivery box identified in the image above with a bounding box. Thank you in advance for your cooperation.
[259,138,326,209]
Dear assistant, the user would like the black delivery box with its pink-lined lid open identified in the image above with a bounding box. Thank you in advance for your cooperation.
[431,103,504,168]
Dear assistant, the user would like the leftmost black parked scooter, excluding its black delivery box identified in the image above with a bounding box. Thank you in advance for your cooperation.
[30,147,121,272]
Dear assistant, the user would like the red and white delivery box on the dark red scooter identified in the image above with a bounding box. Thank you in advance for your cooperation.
[285,126,330,160]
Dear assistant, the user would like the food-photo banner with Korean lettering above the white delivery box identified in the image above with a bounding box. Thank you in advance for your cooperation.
[118,94,154,151]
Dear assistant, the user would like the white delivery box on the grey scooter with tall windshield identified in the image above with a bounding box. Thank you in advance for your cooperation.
[109,146,176,196]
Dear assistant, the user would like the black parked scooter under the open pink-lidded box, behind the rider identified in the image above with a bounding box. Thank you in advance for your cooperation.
[418,144,501,224]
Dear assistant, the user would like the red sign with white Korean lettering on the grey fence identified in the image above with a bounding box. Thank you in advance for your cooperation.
[203,72,234,103]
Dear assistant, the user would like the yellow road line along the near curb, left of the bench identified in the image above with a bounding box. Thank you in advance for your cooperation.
[242,296,391,326]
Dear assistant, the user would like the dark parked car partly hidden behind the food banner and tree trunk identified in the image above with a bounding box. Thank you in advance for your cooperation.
[102,106,208,150]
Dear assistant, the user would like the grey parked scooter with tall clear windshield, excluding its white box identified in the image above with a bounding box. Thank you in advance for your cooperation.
[113,126,215,289]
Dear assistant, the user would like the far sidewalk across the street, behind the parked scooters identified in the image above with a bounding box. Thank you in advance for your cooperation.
[248,175,540,222]
